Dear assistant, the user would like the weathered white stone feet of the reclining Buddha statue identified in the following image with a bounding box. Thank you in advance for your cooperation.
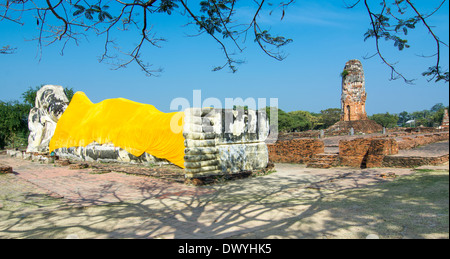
[183,108,269,177]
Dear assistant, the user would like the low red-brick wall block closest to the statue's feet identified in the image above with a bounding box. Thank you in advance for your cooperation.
[267,139,325,164]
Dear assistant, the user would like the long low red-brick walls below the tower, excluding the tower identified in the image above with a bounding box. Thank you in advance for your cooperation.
[268,131,449,171]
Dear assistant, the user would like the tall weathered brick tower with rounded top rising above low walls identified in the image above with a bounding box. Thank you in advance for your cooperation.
[341,59,367,121]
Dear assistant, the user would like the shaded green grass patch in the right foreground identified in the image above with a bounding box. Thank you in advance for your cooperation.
[321,170,449,238]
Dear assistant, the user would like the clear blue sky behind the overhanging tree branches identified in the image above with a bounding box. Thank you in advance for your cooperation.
[0,0,449,115]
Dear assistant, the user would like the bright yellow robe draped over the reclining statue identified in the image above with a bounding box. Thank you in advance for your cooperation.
[50,92,184,168]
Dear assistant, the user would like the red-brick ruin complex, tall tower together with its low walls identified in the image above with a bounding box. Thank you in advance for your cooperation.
[268,60,449,168]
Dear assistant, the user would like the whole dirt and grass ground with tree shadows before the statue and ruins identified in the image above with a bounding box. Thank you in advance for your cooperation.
[0,155,449,239]
